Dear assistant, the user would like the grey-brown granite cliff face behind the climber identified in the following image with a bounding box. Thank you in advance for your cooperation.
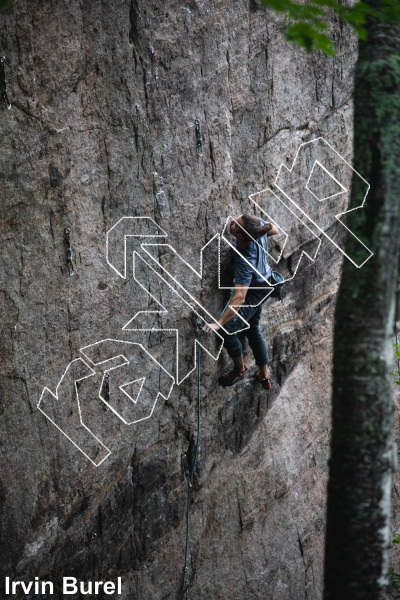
[0,0,356,600]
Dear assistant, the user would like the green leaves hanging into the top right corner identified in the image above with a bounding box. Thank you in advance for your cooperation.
[261,0,400,56]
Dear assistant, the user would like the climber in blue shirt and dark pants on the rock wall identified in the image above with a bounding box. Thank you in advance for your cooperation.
[203,214,279,390]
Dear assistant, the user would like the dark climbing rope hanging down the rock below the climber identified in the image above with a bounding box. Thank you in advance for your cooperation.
[179,329,201,600]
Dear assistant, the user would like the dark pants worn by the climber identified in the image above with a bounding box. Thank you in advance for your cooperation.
[218,290,268,366]
